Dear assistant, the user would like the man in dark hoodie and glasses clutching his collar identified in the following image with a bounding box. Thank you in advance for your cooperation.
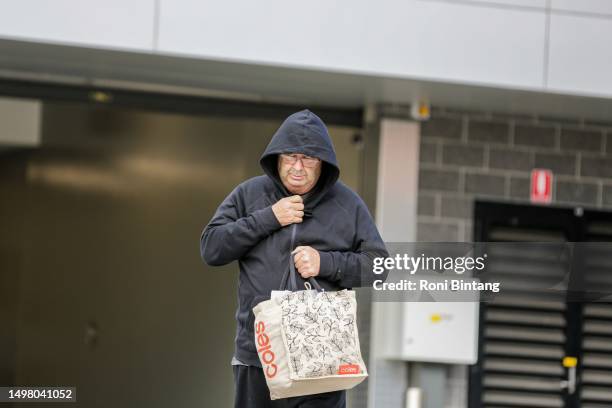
[200,110,388,408]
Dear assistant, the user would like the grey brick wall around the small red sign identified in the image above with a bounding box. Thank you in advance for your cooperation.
[418,108,612,241]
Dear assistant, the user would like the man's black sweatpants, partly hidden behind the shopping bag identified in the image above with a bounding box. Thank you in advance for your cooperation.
[232,365,346,408]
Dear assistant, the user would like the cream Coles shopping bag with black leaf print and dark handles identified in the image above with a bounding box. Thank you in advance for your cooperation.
[253,224,368,400]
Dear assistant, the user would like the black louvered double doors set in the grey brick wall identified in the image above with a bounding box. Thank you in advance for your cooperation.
[469,201,612,408]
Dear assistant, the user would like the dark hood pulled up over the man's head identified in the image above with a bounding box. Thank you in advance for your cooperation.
[259,109,340,215]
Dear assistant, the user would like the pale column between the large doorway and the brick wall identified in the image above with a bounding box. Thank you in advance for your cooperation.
[368,119,420,408]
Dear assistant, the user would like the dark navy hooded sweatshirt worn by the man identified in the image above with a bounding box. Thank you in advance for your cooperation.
[200,110,388,367]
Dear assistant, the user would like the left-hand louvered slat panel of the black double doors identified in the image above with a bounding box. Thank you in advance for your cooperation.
[482,228,567,408]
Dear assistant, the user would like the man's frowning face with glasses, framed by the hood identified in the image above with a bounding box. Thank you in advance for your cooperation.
[278,153,322,194]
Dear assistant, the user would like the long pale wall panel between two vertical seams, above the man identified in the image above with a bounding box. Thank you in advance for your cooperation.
[159,0,545,88]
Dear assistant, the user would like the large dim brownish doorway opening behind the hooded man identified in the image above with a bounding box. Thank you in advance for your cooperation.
[0,98,364,407]
